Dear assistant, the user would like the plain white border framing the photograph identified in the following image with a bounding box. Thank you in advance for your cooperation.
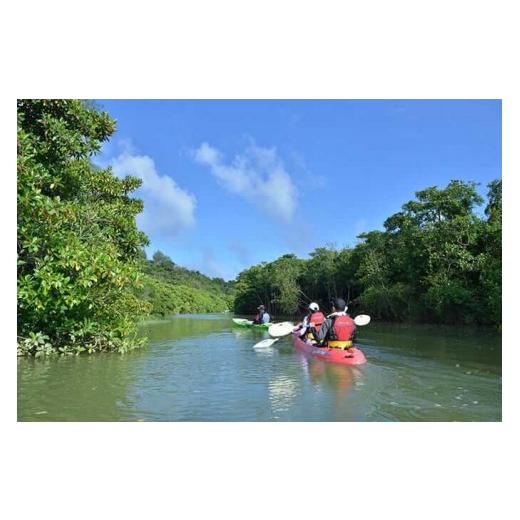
[0,0,520,519]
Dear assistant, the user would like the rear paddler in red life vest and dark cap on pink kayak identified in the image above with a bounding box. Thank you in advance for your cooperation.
[310,298,356,356]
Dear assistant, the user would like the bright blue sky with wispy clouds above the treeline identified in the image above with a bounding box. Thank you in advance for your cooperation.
[96,100,501,279]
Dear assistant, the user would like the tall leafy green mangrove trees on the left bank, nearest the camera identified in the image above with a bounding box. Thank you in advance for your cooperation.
[17,100,149,355]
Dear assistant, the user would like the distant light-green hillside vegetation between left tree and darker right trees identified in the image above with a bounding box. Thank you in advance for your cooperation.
[140,251,233,316]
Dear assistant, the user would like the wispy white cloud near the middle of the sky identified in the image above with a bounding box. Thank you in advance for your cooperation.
[194,143,297,222]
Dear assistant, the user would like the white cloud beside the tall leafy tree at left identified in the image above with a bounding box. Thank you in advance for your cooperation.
[110,143,196,237]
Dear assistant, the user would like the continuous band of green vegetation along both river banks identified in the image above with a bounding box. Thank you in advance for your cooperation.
[17,100,502,355]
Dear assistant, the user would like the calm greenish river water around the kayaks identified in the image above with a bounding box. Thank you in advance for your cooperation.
[18,314,502,421]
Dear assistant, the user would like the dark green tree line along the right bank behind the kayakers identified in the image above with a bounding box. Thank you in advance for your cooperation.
[235,180,502,326]
